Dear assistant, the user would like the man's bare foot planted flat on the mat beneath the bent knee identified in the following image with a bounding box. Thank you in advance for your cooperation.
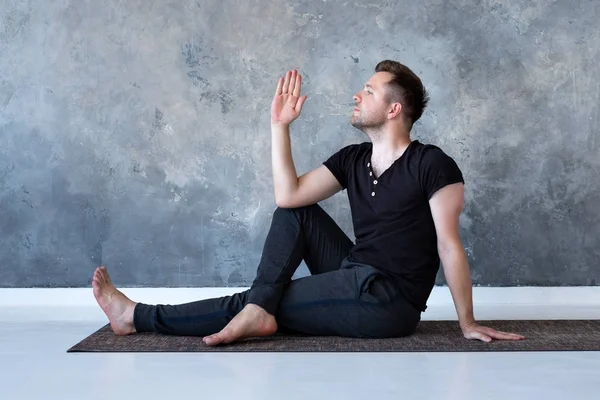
[202,304,277,346]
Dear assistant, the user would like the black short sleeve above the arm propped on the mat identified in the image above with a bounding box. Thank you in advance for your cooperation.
[420,146,465,200]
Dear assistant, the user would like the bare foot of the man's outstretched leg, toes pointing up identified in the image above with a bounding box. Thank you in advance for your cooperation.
[92,267,135,335]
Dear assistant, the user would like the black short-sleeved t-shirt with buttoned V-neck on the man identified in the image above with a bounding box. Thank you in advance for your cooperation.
[323,140,464,311]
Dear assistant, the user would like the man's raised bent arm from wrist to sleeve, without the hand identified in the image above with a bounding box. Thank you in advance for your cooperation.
[271,123,342,208]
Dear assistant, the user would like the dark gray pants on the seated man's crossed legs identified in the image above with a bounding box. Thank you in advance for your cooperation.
[134,205,421,338]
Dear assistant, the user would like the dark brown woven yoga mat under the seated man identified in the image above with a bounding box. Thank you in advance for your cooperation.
[67,320,600,352]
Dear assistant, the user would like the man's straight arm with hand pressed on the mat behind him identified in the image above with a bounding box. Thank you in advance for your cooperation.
[429,182,525,342]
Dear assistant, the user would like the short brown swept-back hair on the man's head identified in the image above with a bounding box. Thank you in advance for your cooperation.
[375,60,429,125]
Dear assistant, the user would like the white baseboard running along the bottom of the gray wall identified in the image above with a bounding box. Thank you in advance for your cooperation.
[0,286,600,307]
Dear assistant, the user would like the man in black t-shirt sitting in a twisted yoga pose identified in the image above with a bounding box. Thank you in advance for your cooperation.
[93,60,523,345]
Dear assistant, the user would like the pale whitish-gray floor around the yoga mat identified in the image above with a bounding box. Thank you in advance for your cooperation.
[0,307,600,400]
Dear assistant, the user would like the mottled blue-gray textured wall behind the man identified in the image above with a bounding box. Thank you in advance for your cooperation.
[0,0,600,287]
